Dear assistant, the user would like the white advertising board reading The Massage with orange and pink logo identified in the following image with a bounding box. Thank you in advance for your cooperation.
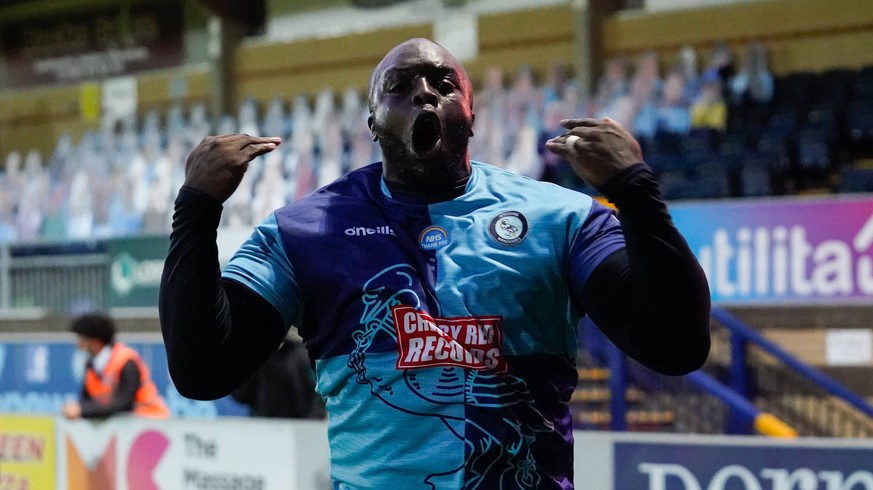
[57,417,332,490]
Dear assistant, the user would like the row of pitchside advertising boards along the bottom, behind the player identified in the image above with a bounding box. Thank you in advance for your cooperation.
[0,414,873,490]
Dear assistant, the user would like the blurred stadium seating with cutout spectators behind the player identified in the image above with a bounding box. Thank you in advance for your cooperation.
[0,55,873,243]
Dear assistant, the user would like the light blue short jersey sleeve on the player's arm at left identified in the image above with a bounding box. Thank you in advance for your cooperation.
[221,214,300,325]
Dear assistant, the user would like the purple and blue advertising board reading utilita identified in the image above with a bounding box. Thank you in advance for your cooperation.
[670,196,873,305]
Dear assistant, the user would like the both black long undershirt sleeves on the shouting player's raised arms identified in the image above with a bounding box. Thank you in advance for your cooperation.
[159,164,710,399]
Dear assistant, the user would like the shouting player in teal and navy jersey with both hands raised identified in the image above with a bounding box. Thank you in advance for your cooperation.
[160,39,710,489]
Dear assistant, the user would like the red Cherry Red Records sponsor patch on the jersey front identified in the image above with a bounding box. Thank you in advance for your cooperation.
[391,306,507,372]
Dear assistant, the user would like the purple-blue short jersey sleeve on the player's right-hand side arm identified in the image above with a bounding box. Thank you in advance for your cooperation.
[570,201,625,292]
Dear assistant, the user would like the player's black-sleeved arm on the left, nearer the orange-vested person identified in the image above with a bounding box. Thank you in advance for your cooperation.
[159,187,284,399]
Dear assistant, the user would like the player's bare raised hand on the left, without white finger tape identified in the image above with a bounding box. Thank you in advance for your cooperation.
[185,134,282,203]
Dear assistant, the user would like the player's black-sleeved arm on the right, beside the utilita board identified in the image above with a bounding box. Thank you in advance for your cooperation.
[590,164,710,374]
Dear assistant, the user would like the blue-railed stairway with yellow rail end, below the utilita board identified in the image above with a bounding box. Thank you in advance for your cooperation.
[582,308,873,437]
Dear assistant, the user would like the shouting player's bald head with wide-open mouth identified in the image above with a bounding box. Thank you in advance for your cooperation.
[369,39,474,190]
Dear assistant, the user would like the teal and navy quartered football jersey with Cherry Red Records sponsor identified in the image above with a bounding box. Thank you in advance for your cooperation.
[223,162,624,489]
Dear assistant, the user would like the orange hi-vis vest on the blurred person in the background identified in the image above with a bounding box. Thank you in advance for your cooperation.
[85,342,170,419]
